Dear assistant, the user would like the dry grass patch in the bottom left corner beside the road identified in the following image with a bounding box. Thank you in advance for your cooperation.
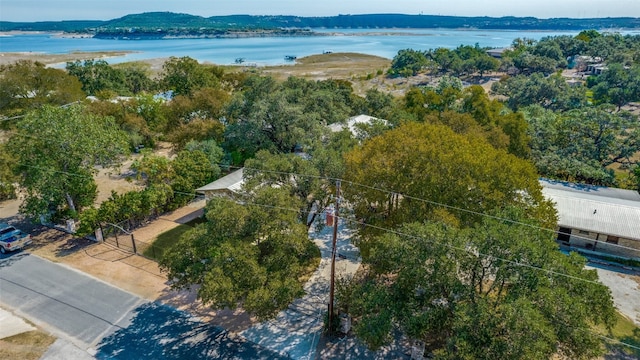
[0,330,56,360]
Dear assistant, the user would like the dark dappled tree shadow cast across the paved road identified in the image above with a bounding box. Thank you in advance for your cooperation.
[96,303,284,359]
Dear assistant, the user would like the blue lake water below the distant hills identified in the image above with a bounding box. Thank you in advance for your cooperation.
[0,29,640,65]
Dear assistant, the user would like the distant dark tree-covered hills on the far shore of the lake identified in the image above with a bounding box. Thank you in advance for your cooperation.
[0,12,640,32]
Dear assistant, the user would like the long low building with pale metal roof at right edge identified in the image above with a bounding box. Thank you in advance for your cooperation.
[540,180,640,259]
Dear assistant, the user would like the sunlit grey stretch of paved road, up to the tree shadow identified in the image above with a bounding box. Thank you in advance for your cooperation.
[0,252,142,349]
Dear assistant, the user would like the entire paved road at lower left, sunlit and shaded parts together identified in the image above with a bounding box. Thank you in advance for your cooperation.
[0,252,282,359]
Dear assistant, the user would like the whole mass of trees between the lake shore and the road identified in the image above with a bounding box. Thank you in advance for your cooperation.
[0,31,640,359]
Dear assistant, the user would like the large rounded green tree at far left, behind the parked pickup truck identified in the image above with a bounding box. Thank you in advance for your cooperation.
[7,106,127,217]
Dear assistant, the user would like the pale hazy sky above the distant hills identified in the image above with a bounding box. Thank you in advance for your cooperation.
[0,0,640,21]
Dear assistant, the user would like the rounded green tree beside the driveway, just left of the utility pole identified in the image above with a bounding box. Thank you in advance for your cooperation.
[160,187,319,319]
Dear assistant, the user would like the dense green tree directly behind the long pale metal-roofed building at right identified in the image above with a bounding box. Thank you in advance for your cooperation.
[523,106,640,186]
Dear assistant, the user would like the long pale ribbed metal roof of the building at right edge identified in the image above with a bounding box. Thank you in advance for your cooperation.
[541,181,640,240]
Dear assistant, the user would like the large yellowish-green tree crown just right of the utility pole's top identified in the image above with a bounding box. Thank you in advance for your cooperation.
[345,123,555,240]
